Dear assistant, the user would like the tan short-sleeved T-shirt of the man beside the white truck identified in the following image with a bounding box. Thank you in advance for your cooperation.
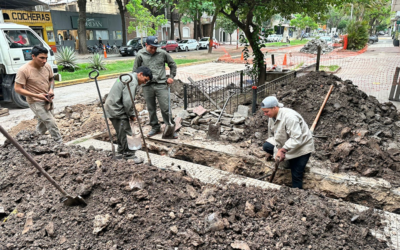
[15,63,53,103]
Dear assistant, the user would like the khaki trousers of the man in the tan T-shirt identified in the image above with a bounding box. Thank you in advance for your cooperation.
[29,102,62,142]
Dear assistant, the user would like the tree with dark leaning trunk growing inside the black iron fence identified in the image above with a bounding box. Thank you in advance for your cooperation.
[216,0,342,85]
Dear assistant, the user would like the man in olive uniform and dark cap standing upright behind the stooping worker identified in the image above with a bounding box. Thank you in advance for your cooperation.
[133,36,178,139]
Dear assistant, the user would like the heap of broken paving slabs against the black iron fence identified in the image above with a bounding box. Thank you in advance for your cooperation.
[176,106,249,142]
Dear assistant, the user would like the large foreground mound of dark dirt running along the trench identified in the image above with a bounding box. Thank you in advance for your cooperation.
[0,132,388,249]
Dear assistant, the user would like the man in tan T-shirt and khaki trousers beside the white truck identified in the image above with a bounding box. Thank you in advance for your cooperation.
[14,46,62,143]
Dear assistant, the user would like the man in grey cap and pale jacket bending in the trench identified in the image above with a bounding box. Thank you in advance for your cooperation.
[261,96,315,189]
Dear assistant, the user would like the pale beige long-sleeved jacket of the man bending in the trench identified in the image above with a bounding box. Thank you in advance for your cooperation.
[267,108,315,160]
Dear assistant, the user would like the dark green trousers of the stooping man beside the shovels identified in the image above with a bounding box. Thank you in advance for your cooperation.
[110,118,136,156]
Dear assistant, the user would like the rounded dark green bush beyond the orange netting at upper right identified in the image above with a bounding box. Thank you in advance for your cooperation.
[347,21,369,50]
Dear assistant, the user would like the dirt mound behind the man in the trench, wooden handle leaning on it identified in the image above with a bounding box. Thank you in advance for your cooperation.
[245,72,400,185]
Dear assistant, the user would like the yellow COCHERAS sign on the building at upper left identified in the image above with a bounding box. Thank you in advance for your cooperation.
[2,10,51,23]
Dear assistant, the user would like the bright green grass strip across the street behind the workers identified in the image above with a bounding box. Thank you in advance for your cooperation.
[58,59,206,81]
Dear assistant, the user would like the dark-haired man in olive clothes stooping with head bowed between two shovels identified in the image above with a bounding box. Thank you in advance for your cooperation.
[104,66,153,164]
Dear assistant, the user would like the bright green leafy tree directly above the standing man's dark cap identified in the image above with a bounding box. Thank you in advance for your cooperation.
[126,0,168,43]
